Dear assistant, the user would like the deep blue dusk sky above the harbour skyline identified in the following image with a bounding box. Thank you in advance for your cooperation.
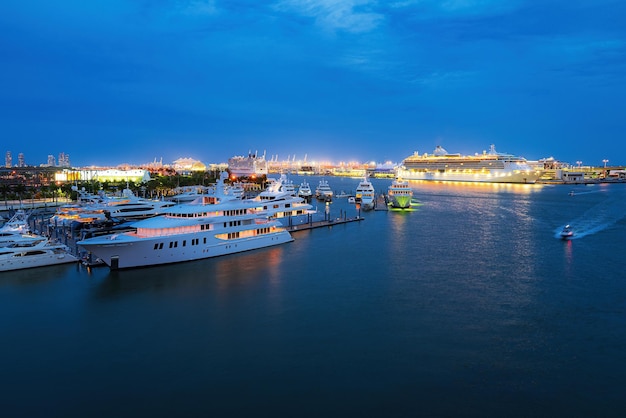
[0,0,626,166]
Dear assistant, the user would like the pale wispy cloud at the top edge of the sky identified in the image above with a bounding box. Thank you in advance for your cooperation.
[275,0,385,33]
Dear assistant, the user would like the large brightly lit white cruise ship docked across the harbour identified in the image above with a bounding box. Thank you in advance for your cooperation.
[396,145,542,183]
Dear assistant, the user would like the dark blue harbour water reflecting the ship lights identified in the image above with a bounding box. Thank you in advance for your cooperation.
[0,177,626,417]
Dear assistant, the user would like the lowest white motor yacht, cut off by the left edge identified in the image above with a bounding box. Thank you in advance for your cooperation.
[0,237,78,271]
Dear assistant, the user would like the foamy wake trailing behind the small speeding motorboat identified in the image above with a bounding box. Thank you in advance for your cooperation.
[554,192,626,239]
